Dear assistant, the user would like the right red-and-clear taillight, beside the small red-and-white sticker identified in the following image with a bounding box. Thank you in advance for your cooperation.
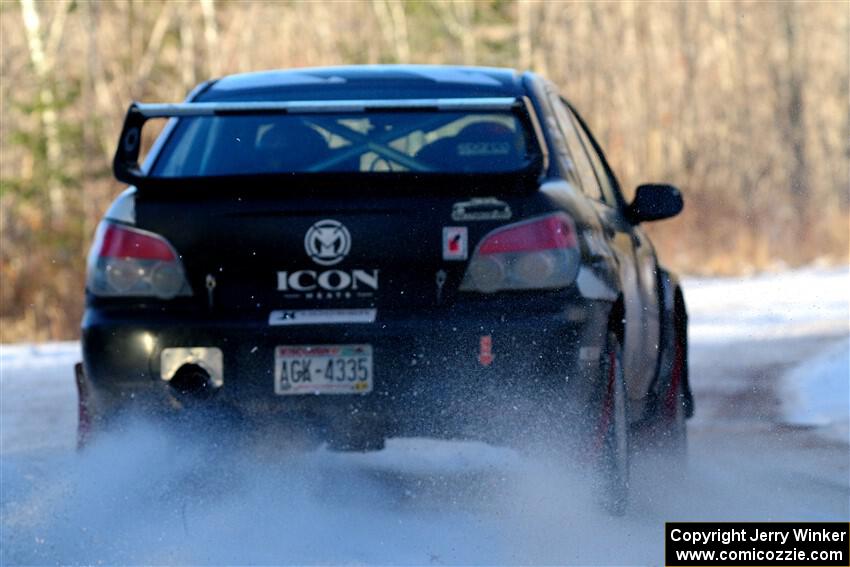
[460,213,581,293]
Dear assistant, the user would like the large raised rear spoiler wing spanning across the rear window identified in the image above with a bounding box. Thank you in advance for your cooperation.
[112,97,549,185]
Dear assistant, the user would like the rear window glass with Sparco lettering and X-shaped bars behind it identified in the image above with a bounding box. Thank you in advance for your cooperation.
[150,111,537,177]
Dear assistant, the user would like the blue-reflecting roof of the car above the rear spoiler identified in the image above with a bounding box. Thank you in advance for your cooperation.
[193,65,526,102]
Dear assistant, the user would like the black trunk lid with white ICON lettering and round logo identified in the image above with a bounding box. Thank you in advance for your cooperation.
[136,184,527,320]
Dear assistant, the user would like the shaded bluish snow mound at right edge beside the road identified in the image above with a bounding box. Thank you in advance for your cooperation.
[781,338,850,442]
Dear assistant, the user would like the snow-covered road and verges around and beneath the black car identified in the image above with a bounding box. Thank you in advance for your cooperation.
[0,268,850,565]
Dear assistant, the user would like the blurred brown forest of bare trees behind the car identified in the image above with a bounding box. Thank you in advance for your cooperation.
[0,0,850,342]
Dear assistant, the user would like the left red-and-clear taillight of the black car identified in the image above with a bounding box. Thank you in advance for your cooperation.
[88,221,192,299]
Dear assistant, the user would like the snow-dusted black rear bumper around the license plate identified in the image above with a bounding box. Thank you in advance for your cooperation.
[82,301,608,437]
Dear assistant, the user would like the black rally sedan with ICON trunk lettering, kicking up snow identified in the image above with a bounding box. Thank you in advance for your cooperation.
[78,66,692,516]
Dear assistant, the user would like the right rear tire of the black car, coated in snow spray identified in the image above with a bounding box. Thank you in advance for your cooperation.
[597,331,631,516]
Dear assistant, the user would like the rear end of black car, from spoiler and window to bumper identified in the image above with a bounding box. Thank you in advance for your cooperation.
[83,71,608,448]
